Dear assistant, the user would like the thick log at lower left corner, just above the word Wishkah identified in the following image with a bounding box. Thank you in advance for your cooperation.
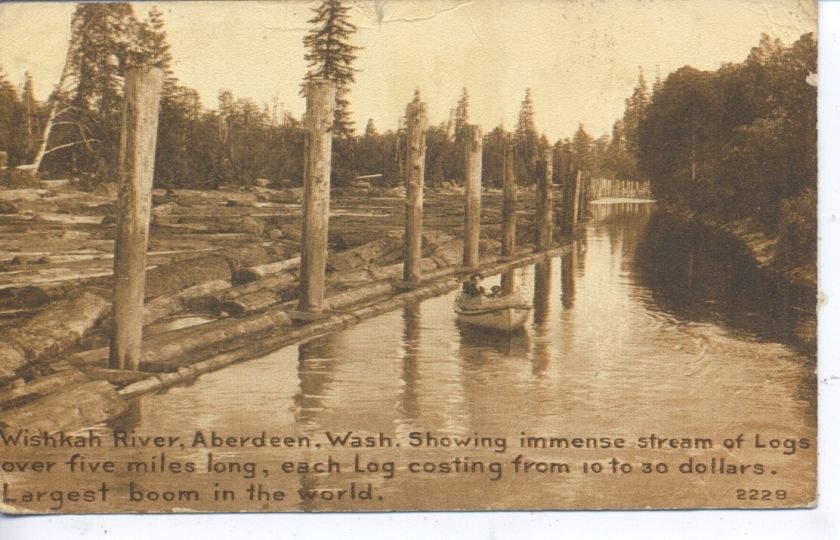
[0,381,126,432]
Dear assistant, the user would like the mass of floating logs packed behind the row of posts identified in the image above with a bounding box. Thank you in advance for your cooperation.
[0,179,576,429]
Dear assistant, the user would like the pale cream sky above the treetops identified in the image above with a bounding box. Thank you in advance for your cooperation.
[0,0,817,140]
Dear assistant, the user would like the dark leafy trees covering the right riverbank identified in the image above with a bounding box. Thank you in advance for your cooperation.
[636,34,817,289]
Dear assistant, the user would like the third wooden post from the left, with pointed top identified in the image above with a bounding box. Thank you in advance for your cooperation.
[403,92,428,283]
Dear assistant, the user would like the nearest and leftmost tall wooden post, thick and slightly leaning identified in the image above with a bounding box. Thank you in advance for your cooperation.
[108,67,163,370]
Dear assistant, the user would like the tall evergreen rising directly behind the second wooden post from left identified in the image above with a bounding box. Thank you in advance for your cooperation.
[303,0,359,137]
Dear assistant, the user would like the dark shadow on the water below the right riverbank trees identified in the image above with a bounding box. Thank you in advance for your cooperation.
[634,211,816,354]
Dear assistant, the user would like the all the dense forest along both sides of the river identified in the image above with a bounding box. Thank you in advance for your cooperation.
[0,0,817,274]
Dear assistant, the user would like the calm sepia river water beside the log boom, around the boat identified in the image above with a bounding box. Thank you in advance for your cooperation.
[1,202,816,510]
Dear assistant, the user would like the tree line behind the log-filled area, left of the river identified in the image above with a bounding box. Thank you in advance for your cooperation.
[0,0,634,189]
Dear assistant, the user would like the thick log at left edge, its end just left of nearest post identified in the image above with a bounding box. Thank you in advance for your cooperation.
[0,292,110,380]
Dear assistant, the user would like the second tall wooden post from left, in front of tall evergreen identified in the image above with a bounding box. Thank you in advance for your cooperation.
[298,79,335,311]
